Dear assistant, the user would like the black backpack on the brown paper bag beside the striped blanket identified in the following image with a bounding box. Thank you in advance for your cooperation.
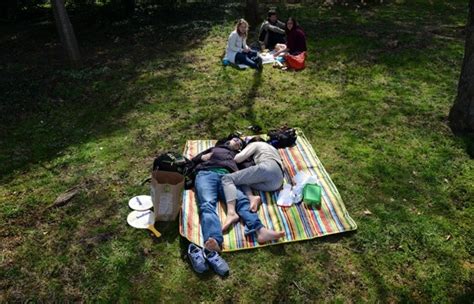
[153,152,194,189]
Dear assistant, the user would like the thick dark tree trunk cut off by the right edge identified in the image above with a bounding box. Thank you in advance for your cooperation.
[449,0,474,133]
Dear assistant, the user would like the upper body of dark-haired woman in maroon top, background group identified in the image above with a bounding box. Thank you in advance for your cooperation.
[273,17,306,57]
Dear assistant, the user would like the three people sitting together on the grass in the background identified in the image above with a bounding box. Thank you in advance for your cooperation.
[225,10,306,70]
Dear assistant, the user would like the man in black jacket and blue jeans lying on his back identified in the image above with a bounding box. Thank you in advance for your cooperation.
[193,137,285,251]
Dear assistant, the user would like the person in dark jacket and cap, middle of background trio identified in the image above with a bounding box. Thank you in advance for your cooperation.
[258,10,285,50]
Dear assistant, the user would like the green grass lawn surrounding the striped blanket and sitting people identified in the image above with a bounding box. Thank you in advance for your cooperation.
[0,0,474,303]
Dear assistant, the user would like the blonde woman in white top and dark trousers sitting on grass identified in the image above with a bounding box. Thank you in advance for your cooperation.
[225,19,262,70]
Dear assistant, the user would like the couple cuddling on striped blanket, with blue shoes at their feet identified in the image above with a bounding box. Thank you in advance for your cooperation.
[188,135,285,276]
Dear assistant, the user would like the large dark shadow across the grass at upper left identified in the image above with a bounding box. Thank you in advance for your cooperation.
[0,7,231,182]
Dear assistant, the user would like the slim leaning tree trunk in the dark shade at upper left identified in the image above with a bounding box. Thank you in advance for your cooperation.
[51,0,81,64]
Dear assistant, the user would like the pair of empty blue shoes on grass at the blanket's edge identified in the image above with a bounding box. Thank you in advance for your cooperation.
[188,243,229,277]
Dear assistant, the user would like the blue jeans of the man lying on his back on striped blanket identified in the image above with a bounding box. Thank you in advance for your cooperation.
[194,171,263,248]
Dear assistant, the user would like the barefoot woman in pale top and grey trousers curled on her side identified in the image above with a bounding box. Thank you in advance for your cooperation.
[222,136,283,231]
